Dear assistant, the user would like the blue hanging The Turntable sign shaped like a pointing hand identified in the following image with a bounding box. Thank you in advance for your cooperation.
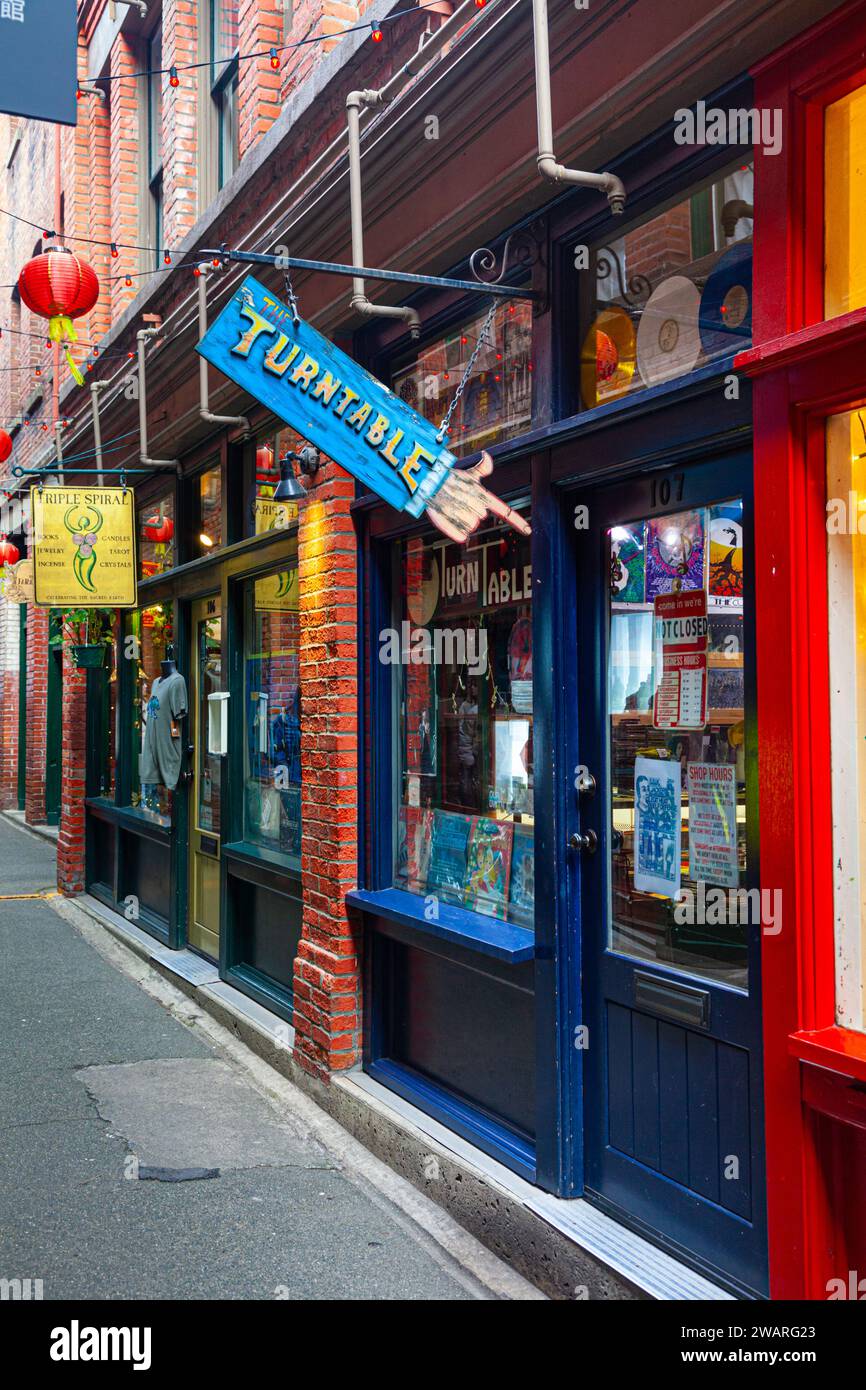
[197,275,530,541]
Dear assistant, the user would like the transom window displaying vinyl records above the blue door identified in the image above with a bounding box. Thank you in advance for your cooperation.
[583,164,753,410]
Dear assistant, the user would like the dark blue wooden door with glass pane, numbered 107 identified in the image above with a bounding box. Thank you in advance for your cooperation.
[571,457,767,1294]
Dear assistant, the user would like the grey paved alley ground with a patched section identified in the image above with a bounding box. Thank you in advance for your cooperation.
[0,820,542,1300]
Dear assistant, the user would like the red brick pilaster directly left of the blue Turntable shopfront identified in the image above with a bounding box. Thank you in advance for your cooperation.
[295,463,360,1076]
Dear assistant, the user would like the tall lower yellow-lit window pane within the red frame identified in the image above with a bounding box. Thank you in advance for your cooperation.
[827,410,866,1031]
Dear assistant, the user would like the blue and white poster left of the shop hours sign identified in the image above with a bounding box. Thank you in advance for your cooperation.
[634,758,683,898]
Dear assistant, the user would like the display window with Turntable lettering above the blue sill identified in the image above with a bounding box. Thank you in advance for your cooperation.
[394,527,535,927]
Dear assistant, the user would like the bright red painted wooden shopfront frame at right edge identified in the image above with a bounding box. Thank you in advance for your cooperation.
[737,3,866,1298]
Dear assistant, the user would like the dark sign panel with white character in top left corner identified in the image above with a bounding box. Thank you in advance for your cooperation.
[0,0,78,125]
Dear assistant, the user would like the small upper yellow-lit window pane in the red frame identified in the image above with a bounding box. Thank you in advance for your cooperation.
[824,86,866,318]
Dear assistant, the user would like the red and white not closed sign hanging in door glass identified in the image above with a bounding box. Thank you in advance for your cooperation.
[652,589,709,728]
